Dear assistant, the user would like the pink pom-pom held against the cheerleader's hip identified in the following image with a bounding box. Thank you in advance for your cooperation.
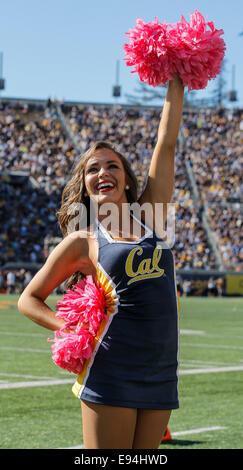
[48,275,107,374]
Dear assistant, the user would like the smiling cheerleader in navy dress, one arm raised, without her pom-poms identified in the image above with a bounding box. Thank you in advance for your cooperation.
[18,76,184,449]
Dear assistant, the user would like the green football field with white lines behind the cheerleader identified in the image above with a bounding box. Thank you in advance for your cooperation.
[0,294,243,449]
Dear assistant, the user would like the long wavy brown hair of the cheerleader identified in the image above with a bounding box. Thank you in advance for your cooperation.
[56,140,138,289]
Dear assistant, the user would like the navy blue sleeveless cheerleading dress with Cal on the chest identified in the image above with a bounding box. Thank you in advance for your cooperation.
[73,211,179,409]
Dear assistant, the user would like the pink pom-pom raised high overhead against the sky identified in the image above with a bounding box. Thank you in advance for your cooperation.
[124,10,226,91]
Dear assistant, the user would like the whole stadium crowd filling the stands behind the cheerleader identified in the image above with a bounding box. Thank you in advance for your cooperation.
[0,100,243,291]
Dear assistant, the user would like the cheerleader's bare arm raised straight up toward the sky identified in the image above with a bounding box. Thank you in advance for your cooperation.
[138,75,184,205]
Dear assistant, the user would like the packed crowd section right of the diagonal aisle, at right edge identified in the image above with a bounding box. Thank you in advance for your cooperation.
[182,108,243,271]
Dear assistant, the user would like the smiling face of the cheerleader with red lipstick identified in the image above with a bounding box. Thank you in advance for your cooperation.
[84,148,127,204]
